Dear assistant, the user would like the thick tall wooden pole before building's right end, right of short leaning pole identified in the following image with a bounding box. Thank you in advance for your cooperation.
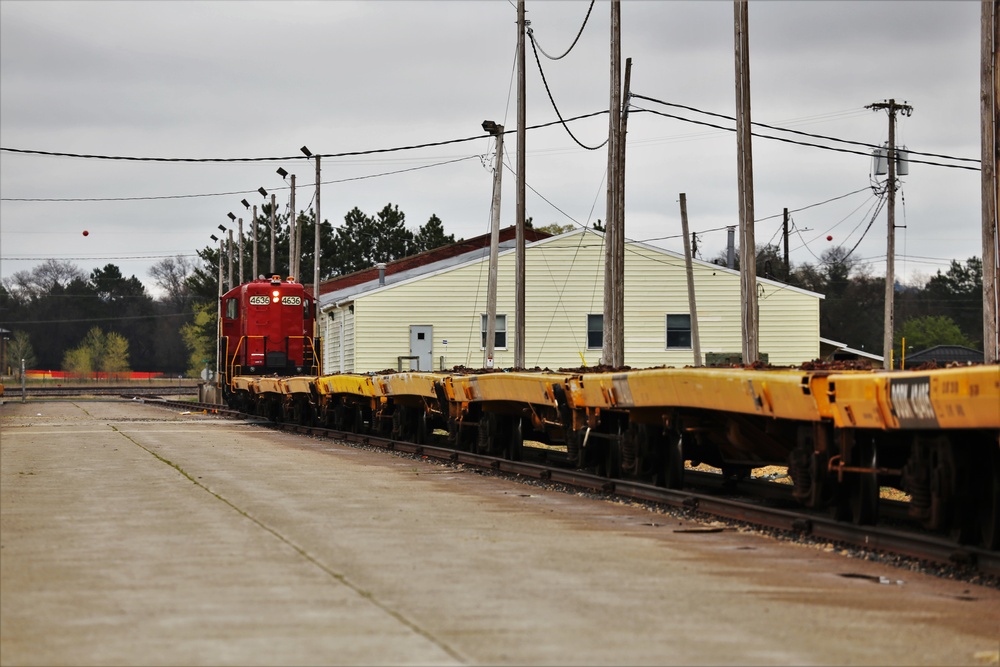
[733,0,759,364]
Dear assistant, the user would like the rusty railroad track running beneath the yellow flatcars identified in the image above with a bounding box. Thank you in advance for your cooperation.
[150,400,1000,578]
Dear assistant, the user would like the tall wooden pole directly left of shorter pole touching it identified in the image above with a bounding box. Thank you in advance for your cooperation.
[601,0,624,366]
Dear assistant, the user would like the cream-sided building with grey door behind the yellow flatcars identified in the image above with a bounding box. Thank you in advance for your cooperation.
[320,230,822,373]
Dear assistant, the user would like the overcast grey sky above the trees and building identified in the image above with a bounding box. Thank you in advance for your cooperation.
[0,0,982,298]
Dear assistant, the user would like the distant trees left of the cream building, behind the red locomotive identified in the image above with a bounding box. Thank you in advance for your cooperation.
[0,204,455,376]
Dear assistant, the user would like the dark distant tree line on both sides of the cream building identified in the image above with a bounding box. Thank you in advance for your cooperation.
[0,203,982,376]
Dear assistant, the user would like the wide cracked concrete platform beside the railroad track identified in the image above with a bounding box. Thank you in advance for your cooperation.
[0,401,1000,665]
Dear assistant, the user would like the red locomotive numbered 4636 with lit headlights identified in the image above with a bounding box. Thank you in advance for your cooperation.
[219,276,319,391]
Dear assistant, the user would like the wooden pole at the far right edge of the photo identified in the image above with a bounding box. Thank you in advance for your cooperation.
[980,0,1000,364]
